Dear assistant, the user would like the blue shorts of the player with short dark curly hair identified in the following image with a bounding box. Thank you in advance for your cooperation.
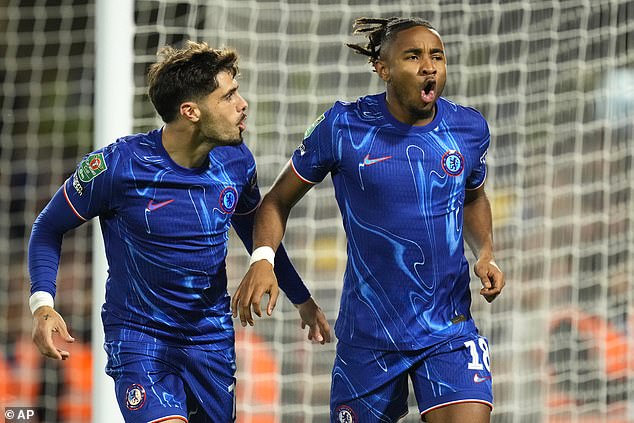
[105,341,236,423]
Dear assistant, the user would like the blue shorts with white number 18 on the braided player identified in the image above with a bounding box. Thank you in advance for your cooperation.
[330,331,493,423]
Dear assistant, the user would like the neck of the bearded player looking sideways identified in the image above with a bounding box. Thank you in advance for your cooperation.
[162,123,212,169]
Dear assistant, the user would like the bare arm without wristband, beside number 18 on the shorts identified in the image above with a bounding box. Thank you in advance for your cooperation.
[464,186,505,302]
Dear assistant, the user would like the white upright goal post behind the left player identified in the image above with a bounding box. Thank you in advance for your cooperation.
[92,0,134,423]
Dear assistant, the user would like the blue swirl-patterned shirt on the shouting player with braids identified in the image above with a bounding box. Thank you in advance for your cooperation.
[292,93,490,350]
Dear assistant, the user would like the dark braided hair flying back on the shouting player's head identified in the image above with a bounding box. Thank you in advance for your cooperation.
[346,17,435,65]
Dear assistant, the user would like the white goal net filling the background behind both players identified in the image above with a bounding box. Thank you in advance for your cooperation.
[0,0,634,423]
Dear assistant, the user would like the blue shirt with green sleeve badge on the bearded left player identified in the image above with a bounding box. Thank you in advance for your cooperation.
[63,130,260,349]
